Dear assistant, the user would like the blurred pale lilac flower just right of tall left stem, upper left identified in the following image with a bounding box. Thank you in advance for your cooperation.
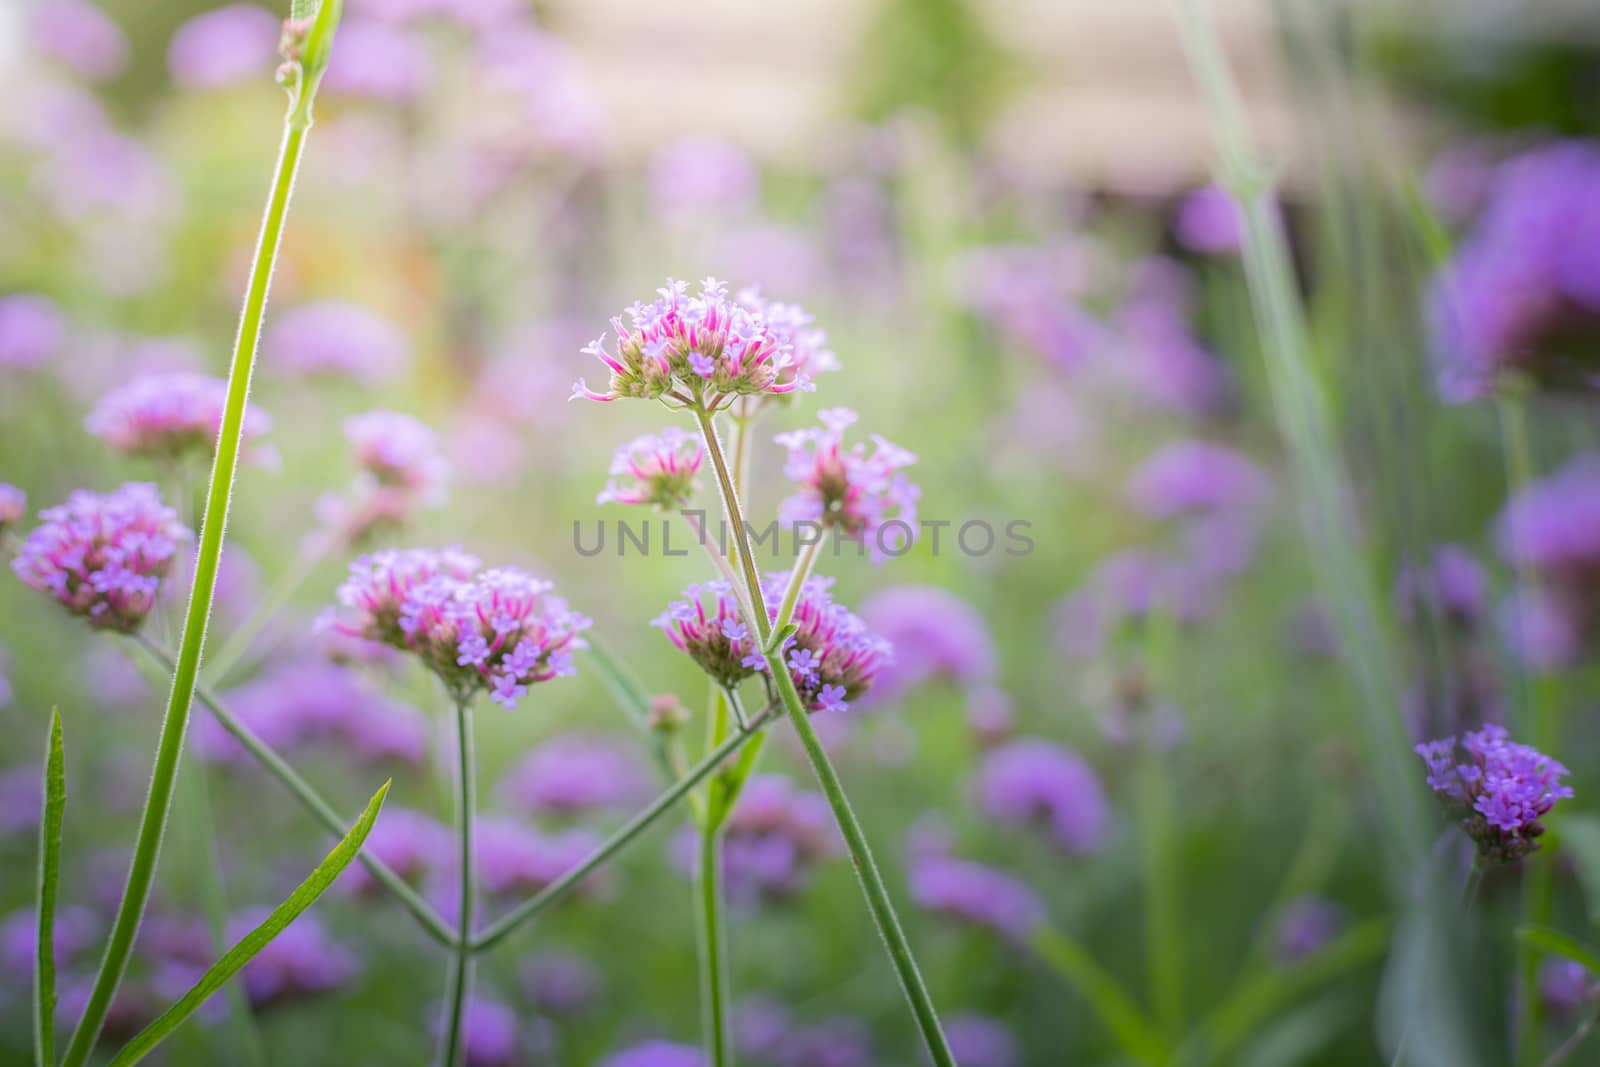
[261,301,411,386]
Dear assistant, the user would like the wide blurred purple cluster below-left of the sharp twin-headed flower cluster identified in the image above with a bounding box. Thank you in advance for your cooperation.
[195,661,427,764]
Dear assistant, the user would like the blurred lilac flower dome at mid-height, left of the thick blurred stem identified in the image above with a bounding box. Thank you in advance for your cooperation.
[1128,440,1269,520]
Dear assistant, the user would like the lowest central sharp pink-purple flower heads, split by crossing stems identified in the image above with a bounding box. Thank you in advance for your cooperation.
[651,571,893,712]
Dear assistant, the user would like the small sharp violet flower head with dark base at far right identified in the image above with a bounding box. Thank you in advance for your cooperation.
[1416,723,1573,864]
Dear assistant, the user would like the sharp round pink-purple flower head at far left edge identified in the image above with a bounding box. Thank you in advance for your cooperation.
[11,483,190,633]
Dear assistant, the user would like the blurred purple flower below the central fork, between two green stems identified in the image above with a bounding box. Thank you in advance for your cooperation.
[677,774,838,905]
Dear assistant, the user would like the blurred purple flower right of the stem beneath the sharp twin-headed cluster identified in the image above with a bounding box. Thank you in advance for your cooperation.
[499,734,653,814]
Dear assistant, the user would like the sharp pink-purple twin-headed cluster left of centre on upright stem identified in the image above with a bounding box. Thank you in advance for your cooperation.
[334,549,589,709]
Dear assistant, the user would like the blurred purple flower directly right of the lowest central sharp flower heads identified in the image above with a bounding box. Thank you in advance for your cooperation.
[861,585,995,704]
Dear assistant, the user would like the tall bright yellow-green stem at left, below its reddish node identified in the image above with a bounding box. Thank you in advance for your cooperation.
[62,116,309,1067]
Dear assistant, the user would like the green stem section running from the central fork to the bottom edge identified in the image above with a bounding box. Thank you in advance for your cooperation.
[766,649,955,1067]
